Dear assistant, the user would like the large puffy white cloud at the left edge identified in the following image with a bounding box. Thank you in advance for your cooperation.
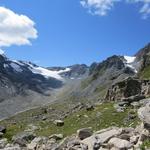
[0,7,37,47]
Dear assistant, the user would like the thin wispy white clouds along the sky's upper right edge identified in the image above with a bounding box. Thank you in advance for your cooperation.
[80,0,150,19]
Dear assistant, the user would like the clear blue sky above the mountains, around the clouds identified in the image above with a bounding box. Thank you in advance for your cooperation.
[0,0,150,66]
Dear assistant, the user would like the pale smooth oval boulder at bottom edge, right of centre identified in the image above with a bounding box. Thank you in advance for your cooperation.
[108,137,133,150]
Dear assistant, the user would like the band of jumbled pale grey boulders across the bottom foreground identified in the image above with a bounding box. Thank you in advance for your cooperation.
[0,102,150,150]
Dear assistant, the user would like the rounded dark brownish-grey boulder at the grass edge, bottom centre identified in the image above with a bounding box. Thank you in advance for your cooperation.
[77,128,93,140]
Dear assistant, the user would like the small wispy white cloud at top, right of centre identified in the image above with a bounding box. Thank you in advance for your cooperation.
[80,0,120,16]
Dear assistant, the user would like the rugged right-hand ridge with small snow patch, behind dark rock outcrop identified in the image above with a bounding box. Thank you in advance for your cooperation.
[62,44,150,102]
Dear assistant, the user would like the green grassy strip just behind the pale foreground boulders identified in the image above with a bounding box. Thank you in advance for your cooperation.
[0,103,139,140]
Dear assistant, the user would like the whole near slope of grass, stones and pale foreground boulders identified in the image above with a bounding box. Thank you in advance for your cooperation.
[0,99,150,150]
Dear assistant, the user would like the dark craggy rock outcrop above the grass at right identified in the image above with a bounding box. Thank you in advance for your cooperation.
[105,77,150,103]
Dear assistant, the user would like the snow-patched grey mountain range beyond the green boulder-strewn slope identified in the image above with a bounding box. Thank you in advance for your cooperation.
[0,44,150,119]
